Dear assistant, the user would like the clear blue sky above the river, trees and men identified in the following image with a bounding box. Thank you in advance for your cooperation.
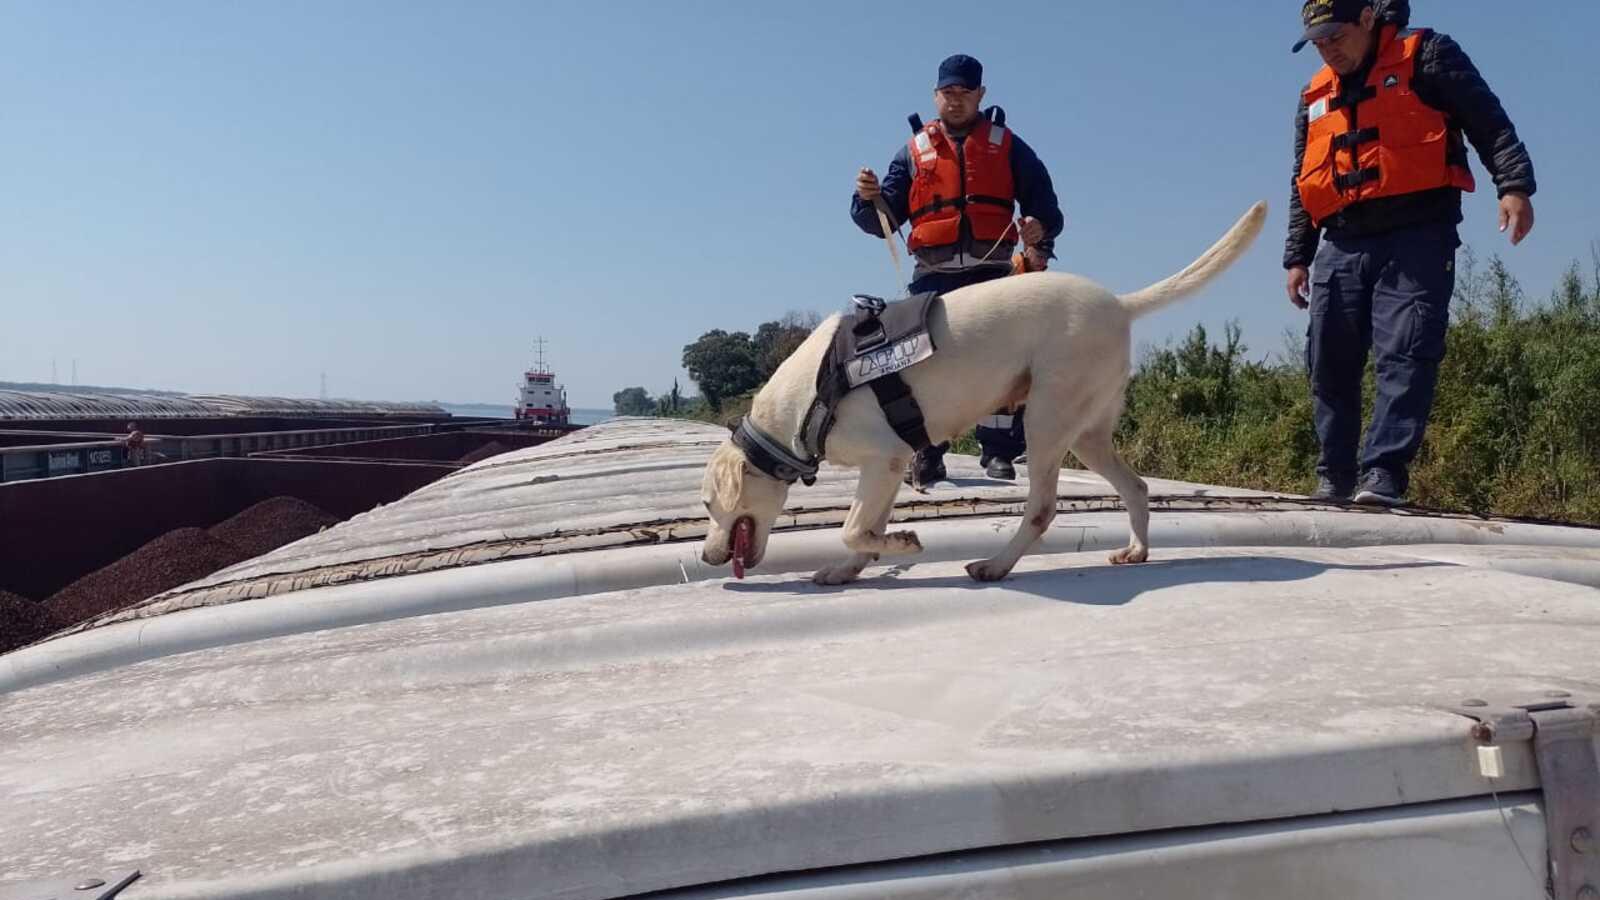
[0,0,1600,407]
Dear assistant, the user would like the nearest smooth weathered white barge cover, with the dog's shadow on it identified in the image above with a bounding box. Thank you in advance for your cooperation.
[0,538,1600,898]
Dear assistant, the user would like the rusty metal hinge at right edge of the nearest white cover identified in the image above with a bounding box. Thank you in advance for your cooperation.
[1454,690,1600,900]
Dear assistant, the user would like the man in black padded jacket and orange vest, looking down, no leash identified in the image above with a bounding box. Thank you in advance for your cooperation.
[1283,0,1536,506]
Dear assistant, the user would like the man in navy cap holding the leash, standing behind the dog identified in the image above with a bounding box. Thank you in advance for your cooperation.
[850,54,1064,484]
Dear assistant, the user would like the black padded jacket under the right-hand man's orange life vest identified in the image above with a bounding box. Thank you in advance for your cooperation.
[1283,32,1538,269]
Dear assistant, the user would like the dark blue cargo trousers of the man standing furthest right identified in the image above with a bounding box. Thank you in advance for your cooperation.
[1306,224,1461,490]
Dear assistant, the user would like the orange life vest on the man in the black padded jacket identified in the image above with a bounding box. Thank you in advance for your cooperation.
[1296,26,1477,226]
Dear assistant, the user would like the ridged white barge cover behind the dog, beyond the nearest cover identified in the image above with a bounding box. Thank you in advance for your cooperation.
[62,420,1388,625]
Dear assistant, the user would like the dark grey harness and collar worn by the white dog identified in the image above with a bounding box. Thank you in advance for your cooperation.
[733,291,939,485]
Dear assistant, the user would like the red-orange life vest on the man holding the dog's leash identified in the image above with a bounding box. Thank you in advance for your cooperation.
[909,119,1016,251]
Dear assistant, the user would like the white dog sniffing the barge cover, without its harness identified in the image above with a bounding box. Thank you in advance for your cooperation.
[701,203,1267,585]
